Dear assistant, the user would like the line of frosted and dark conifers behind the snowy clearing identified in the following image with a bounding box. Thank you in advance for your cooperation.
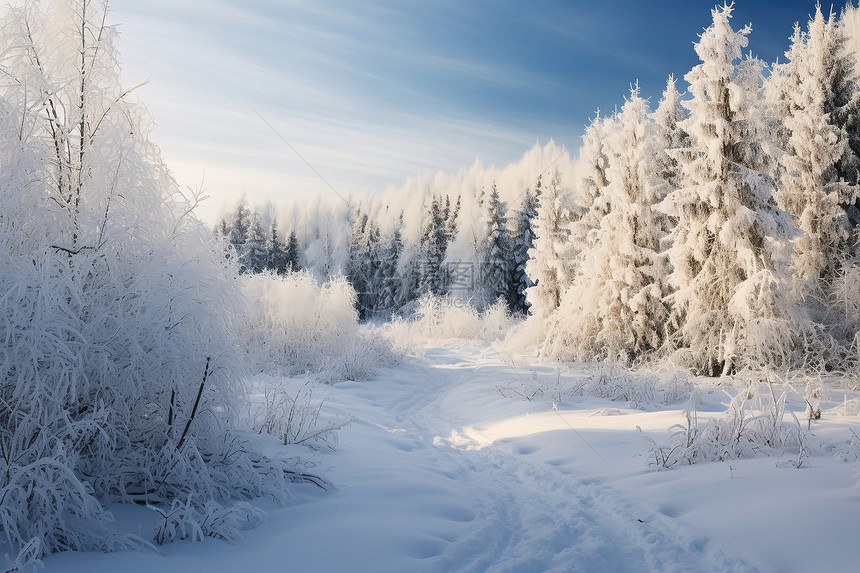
[225,5,860,375]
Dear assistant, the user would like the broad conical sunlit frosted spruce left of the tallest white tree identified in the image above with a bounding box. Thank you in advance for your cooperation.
[563,85,668,363]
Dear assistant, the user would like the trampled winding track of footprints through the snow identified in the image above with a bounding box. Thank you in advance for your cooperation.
[320,348,755,573]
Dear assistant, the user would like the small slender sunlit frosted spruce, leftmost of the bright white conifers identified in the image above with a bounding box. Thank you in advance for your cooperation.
[526,169,572,319]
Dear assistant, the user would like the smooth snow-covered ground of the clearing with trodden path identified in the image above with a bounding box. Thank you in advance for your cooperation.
[45,341,860,573]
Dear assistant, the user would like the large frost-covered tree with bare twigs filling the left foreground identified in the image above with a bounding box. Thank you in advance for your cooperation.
[0,0,294,566]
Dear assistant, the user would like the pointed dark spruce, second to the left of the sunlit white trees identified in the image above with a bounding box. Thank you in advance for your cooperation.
[476,182,515,309]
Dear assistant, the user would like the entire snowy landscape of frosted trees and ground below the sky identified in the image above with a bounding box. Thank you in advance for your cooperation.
[0,0,860,572]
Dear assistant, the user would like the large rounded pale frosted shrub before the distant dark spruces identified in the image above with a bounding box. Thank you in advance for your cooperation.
[239,271,395,382]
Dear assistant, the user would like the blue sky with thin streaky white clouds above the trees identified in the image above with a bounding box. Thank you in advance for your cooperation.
[111,0,828,221]
